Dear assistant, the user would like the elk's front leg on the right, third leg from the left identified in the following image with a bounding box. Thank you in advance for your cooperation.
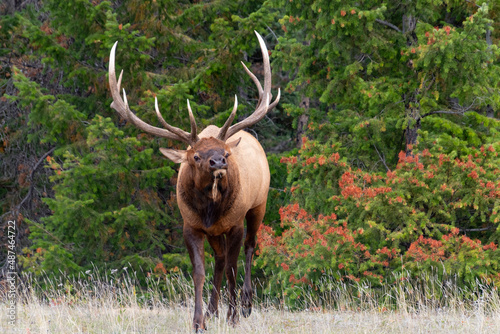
[226,222,243,325]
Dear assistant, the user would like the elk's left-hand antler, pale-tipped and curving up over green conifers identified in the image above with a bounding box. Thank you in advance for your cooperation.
[109,42,199,146]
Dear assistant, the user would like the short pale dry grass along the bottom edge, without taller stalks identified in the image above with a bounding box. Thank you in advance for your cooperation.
[8,303,500,334]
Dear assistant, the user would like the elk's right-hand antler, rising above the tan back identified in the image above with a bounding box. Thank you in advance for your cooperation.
[217,31,281,141]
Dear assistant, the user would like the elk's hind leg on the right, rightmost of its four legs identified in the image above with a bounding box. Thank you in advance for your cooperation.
[241,202,266,318]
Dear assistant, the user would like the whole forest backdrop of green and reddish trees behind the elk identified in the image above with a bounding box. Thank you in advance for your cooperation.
[0,0,500,300]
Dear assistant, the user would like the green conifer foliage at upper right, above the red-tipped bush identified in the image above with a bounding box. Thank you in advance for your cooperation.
[273,0,500,170]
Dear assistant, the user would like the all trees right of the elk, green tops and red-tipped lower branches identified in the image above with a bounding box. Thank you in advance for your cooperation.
[249,0,500,306]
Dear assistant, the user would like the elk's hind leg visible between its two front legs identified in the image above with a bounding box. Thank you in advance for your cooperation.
[206,235,226,317]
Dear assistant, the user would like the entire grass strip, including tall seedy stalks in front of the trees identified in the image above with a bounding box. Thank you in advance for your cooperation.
[0,273,500,334]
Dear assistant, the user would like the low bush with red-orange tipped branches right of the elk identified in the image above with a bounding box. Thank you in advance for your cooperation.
[256,142,500,302]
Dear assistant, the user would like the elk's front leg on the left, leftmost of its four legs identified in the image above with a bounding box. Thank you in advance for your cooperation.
[184,226,206,332]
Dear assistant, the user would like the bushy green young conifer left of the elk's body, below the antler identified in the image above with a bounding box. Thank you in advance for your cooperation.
[23,116,179,271]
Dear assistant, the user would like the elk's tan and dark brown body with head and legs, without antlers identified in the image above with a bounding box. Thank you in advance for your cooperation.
[172,125,270,330]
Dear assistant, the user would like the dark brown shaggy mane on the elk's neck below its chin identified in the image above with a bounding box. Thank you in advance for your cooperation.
[178,163,241,228]
